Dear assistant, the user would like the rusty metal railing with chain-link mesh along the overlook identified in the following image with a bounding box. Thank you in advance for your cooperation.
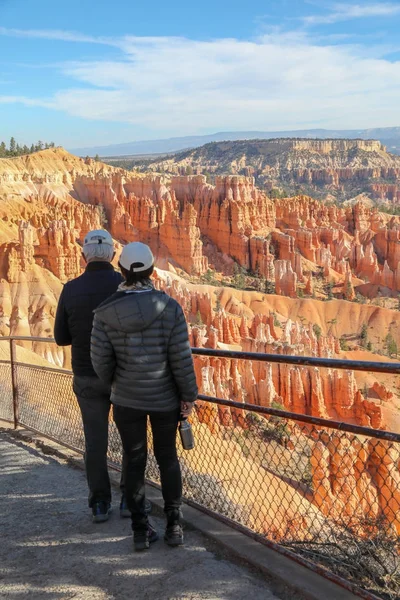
[0,336,400,600]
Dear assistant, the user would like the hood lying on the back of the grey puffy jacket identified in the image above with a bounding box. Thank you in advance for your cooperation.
[94,290,171,333]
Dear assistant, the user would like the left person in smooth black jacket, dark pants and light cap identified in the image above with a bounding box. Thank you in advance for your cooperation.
[54,230,125,523]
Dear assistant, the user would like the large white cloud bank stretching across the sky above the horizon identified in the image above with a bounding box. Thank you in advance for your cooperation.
[0,32,400,135]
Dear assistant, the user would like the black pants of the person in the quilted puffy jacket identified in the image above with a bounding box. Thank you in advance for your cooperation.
[114,405,182,531]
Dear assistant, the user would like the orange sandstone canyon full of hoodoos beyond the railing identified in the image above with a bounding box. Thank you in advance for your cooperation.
[0,141,400,539]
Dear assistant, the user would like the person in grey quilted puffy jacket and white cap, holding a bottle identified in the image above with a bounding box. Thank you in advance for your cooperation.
[91,242,198,550]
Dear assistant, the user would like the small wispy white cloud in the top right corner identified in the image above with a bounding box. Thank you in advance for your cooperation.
[302,2,400,25]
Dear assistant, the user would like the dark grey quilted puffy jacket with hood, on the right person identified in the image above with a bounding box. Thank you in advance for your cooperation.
[91,290,198,412]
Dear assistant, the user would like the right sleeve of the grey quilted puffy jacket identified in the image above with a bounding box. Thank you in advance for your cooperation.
[168,304,198,402]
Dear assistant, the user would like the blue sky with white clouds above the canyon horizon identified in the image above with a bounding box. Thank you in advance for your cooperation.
[0,0,400,148]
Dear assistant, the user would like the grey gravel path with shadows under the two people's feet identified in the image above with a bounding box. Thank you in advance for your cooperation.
[0,432,279,600]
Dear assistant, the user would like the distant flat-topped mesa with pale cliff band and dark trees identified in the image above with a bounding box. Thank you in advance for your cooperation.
[130,138,400,200]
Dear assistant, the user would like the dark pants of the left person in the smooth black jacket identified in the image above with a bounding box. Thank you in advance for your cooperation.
[73,375,125,507]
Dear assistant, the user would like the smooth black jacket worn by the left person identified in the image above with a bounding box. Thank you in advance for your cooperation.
[54,261,123,377]
